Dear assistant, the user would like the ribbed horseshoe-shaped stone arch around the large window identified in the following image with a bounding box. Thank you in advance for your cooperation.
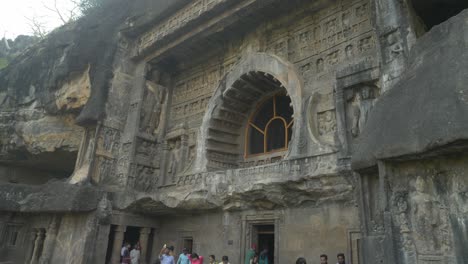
[194,53,304,171]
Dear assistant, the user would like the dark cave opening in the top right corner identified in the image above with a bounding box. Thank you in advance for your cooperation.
[410,0,468,34]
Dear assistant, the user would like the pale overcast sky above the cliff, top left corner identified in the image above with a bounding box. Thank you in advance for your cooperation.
[0,0,73,39]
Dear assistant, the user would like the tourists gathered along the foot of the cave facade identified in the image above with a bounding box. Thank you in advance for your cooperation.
[120,243,345,264]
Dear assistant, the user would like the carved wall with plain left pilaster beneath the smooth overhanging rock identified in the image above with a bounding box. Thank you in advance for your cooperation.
[361,155,468,264]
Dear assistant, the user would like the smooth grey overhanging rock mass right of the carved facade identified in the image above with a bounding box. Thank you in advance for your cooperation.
[352,10,468,169]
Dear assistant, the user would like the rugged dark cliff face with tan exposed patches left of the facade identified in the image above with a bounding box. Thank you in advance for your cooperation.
[0,1,133,182]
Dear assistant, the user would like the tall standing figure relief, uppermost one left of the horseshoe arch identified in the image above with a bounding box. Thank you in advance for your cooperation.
[140,81,167,135]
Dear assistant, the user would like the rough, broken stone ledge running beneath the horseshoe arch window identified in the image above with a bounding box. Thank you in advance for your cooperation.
[115,153,354,214]
